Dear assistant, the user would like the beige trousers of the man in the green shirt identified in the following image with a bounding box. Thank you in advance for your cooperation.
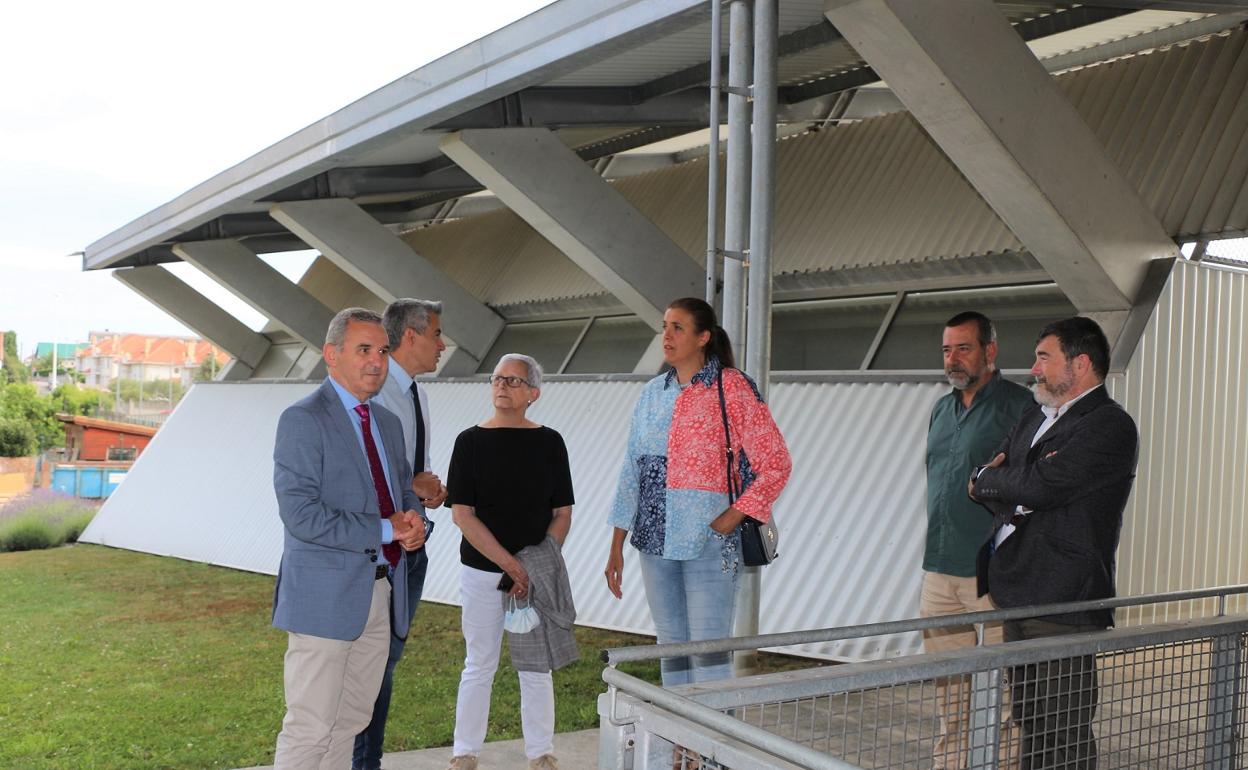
[919,572,1013,770]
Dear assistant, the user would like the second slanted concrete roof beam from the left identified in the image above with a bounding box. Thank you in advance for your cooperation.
[173,240,337,351]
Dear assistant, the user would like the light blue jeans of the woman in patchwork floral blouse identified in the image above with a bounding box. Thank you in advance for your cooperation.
[640,530,741,688]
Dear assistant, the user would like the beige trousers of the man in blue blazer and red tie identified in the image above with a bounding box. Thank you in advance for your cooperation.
[273,580,391,770]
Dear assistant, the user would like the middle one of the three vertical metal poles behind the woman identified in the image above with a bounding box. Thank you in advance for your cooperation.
[720,0,753,356]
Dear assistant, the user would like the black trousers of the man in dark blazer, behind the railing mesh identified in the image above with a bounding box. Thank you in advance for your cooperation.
[1003,619,1104,770]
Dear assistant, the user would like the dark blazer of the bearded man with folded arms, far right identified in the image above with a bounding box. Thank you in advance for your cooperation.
[975,387,1139,626]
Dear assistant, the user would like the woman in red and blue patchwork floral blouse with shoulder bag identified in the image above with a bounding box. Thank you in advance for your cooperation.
[607,297,791,686]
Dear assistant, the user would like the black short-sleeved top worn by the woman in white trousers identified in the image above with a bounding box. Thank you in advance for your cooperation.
[447,426,574,573]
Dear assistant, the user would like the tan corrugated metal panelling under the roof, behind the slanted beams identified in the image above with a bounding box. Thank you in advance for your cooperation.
[406,30,1248,305]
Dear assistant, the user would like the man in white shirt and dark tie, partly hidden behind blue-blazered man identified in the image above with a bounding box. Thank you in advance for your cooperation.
[351,298,447,770]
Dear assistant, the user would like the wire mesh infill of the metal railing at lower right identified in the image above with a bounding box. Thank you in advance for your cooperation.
[725,636,1248,770]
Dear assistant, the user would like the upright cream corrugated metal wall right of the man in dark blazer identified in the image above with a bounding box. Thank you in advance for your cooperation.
[1111,263,1248,621]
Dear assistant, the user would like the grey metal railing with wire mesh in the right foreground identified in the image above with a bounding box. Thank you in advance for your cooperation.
[599,585,1248,770]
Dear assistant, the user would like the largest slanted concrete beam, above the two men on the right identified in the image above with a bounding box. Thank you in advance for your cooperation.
[824,0,1177,312]
